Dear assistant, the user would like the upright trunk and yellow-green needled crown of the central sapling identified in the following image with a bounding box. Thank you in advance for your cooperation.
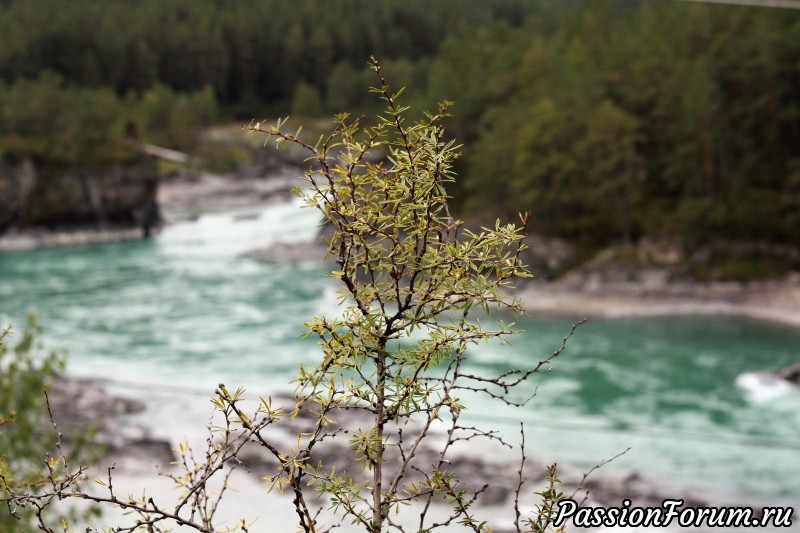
[247,58,544,533]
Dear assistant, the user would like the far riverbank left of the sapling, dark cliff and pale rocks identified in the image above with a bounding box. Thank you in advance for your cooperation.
[0,122,305,252]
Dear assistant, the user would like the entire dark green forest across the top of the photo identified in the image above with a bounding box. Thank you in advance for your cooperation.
[0,0,800,251]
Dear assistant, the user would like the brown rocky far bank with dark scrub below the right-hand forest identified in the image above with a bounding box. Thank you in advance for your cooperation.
[518,239,800,326]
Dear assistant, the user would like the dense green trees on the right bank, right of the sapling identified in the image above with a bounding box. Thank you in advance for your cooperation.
[430,2,800,246]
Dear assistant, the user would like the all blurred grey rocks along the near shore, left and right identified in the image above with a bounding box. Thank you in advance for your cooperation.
[50,376,792,532]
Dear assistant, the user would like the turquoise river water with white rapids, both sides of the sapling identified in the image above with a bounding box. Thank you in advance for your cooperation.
[0,197,800,505]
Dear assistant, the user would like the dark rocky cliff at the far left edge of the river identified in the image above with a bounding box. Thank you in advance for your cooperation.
[0,158,160,240]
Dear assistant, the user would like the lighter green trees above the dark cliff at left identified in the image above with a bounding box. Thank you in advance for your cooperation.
[0,73,217,168]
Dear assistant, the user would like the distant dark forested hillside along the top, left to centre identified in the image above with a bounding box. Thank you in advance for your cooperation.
[0,0,546,108]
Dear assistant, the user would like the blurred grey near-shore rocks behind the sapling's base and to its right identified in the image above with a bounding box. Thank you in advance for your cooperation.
[233,396,756,532]
